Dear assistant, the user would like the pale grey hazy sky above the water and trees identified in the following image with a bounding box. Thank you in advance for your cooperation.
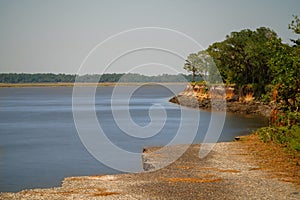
[0,0,300,75]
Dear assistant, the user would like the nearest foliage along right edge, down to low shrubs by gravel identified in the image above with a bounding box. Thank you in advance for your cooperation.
[252,16,300,155]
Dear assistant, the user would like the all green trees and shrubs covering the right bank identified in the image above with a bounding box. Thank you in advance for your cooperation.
[184,16,300,155]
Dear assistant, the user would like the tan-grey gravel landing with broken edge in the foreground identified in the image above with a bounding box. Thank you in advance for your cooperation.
[0,142,300,199]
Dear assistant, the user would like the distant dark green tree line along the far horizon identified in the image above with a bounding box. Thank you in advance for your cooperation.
[0,73,202,83]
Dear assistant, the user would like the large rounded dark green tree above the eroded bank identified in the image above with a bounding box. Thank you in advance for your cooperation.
[207,27,277,97]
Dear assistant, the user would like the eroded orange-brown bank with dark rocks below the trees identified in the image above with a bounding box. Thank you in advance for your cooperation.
[169,85,275,118]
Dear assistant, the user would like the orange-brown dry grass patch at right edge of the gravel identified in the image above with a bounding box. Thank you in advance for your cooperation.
[239,134,300,185]
